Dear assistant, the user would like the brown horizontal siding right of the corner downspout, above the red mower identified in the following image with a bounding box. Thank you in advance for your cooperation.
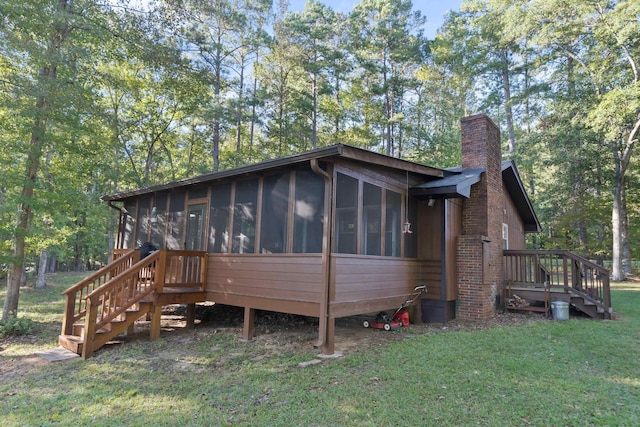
[330,254,440,317]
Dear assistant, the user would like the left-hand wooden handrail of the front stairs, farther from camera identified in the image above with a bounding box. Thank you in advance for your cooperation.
[62,249,140,335]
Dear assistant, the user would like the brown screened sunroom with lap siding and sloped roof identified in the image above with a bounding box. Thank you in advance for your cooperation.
[104,145,444,352]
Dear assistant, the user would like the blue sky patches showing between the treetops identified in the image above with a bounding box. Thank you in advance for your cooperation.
[289,0,462,39]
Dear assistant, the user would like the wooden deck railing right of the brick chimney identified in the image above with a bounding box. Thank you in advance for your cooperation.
[503,250,611,311]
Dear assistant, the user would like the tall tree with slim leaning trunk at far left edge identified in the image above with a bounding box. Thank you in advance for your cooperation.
[2,0,76,319]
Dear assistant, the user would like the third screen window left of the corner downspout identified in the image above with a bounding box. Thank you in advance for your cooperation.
[232,178,258,254]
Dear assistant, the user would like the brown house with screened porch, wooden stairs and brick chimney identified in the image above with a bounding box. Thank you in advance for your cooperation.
[60,114,608,357]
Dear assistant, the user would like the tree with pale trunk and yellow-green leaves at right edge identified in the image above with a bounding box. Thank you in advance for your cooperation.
[530,0,640,280]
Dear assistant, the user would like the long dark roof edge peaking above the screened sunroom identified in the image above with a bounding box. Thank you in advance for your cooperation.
[101,144,446,202]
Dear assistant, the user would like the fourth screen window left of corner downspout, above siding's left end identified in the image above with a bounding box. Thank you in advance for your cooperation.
[207,182,231,253]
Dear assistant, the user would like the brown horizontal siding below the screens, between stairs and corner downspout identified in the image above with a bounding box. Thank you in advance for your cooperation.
[207,254,323,317]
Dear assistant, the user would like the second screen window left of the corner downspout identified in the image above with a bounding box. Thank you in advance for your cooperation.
[260,172,289,253]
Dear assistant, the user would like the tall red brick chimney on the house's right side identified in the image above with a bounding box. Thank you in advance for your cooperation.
[456,114,504,319]
